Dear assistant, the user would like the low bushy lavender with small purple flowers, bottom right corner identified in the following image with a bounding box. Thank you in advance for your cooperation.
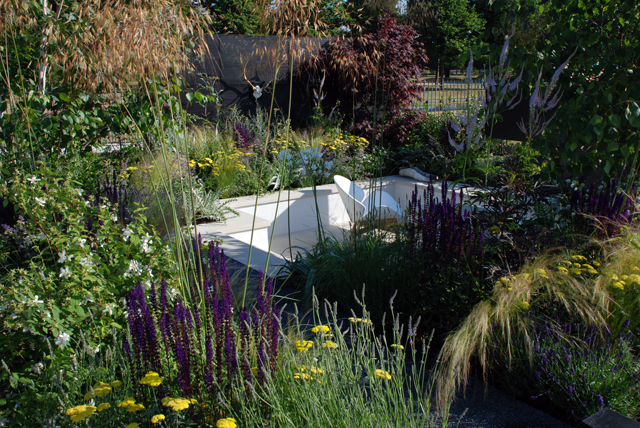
[531,321,640,420]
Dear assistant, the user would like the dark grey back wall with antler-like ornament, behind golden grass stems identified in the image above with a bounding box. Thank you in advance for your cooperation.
[183,34,329,126]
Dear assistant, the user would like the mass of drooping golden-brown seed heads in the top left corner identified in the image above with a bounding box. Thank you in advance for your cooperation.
[0,0,207,92]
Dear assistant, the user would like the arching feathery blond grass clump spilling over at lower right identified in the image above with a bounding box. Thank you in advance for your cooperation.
[435,254,611,407]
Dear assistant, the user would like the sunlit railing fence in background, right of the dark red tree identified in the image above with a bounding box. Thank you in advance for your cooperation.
[413,79,484,111]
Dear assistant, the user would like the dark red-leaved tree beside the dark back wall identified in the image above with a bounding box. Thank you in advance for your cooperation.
[319,13,429,145]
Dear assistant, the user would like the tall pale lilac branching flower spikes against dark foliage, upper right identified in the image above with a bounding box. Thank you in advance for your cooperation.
[447,36,575,152]
